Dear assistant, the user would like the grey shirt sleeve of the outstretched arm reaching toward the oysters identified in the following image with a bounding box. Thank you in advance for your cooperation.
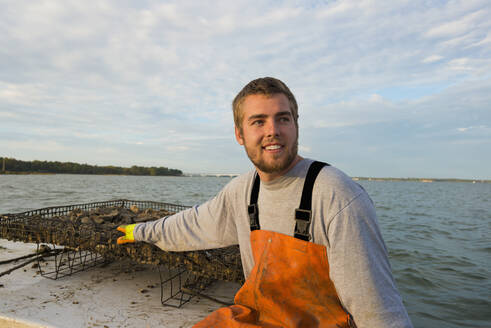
[133,185,238,251]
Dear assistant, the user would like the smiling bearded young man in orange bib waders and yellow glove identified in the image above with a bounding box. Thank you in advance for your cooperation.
[118,78,412,328]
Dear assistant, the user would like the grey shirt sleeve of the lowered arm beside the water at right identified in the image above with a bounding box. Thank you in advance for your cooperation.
[328,191,412,328]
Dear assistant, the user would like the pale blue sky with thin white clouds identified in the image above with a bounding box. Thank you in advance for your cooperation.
[0,0,491,179]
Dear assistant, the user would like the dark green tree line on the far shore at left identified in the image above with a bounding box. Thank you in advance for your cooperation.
[0,157,183,176]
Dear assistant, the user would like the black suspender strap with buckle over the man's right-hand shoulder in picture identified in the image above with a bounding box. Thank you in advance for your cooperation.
[294,162,329,241]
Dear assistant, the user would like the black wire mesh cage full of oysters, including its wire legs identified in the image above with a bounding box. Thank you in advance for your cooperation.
[0,199,244,307]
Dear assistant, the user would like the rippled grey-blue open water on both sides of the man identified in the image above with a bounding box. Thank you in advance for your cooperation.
[0,175,491,328]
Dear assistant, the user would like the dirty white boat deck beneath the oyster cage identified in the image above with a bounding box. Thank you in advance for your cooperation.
[0,239,239,328]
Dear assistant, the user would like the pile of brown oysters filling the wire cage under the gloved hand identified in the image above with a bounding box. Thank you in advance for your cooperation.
[0,205,244,282]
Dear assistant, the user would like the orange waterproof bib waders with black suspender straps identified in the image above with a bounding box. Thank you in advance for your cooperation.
[194,162,355,328]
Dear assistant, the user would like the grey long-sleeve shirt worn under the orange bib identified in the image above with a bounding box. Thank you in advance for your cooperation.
[134,159,412,328]
